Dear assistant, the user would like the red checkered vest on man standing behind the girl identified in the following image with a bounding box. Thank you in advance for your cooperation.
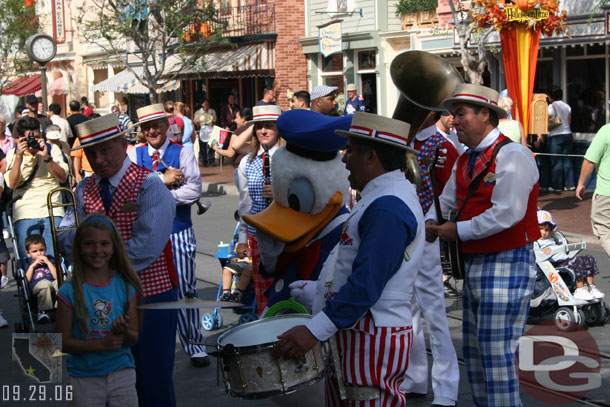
[83,163,178,297]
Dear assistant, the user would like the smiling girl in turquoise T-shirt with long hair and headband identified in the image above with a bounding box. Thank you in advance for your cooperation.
[56,215,142,406]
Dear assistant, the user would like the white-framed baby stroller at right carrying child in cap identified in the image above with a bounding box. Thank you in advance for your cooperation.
[528,231,607,331]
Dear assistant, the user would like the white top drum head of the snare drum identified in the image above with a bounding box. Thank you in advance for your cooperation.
[218,314,312,348]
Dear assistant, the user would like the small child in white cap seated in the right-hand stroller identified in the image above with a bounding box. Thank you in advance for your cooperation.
[537,210,605,301]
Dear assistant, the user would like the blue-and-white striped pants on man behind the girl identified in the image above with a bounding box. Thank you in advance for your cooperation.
[171,227,205,356]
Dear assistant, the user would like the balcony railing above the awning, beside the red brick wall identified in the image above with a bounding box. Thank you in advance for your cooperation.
[185,3,276,41]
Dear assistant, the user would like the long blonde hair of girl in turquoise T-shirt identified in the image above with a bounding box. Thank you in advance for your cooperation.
[71,214,143,336]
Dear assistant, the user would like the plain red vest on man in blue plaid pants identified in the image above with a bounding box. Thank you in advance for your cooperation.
[456,135,540,253]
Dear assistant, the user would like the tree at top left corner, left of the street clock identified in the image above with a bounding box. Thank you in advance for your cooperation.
[0,0,38,94]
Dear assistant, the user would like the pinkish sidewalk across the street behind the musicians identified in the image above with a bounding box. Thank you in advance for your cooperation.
[199,160,599,247]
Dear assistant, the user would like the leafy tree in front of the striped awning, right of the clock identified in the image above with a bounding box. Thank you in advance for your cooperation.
[77,0,225,103]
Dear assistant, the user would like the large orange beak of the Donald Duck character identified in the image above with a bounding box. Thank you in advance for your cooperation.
[242,192,343,253]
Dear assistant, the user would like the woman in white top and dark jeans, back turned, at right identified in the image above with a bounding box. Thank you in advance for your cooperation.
[548,86,576,191]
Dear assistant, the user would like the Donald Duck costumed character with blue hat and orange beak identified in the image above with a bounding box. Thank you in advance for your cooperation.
[242,109,352,306]
